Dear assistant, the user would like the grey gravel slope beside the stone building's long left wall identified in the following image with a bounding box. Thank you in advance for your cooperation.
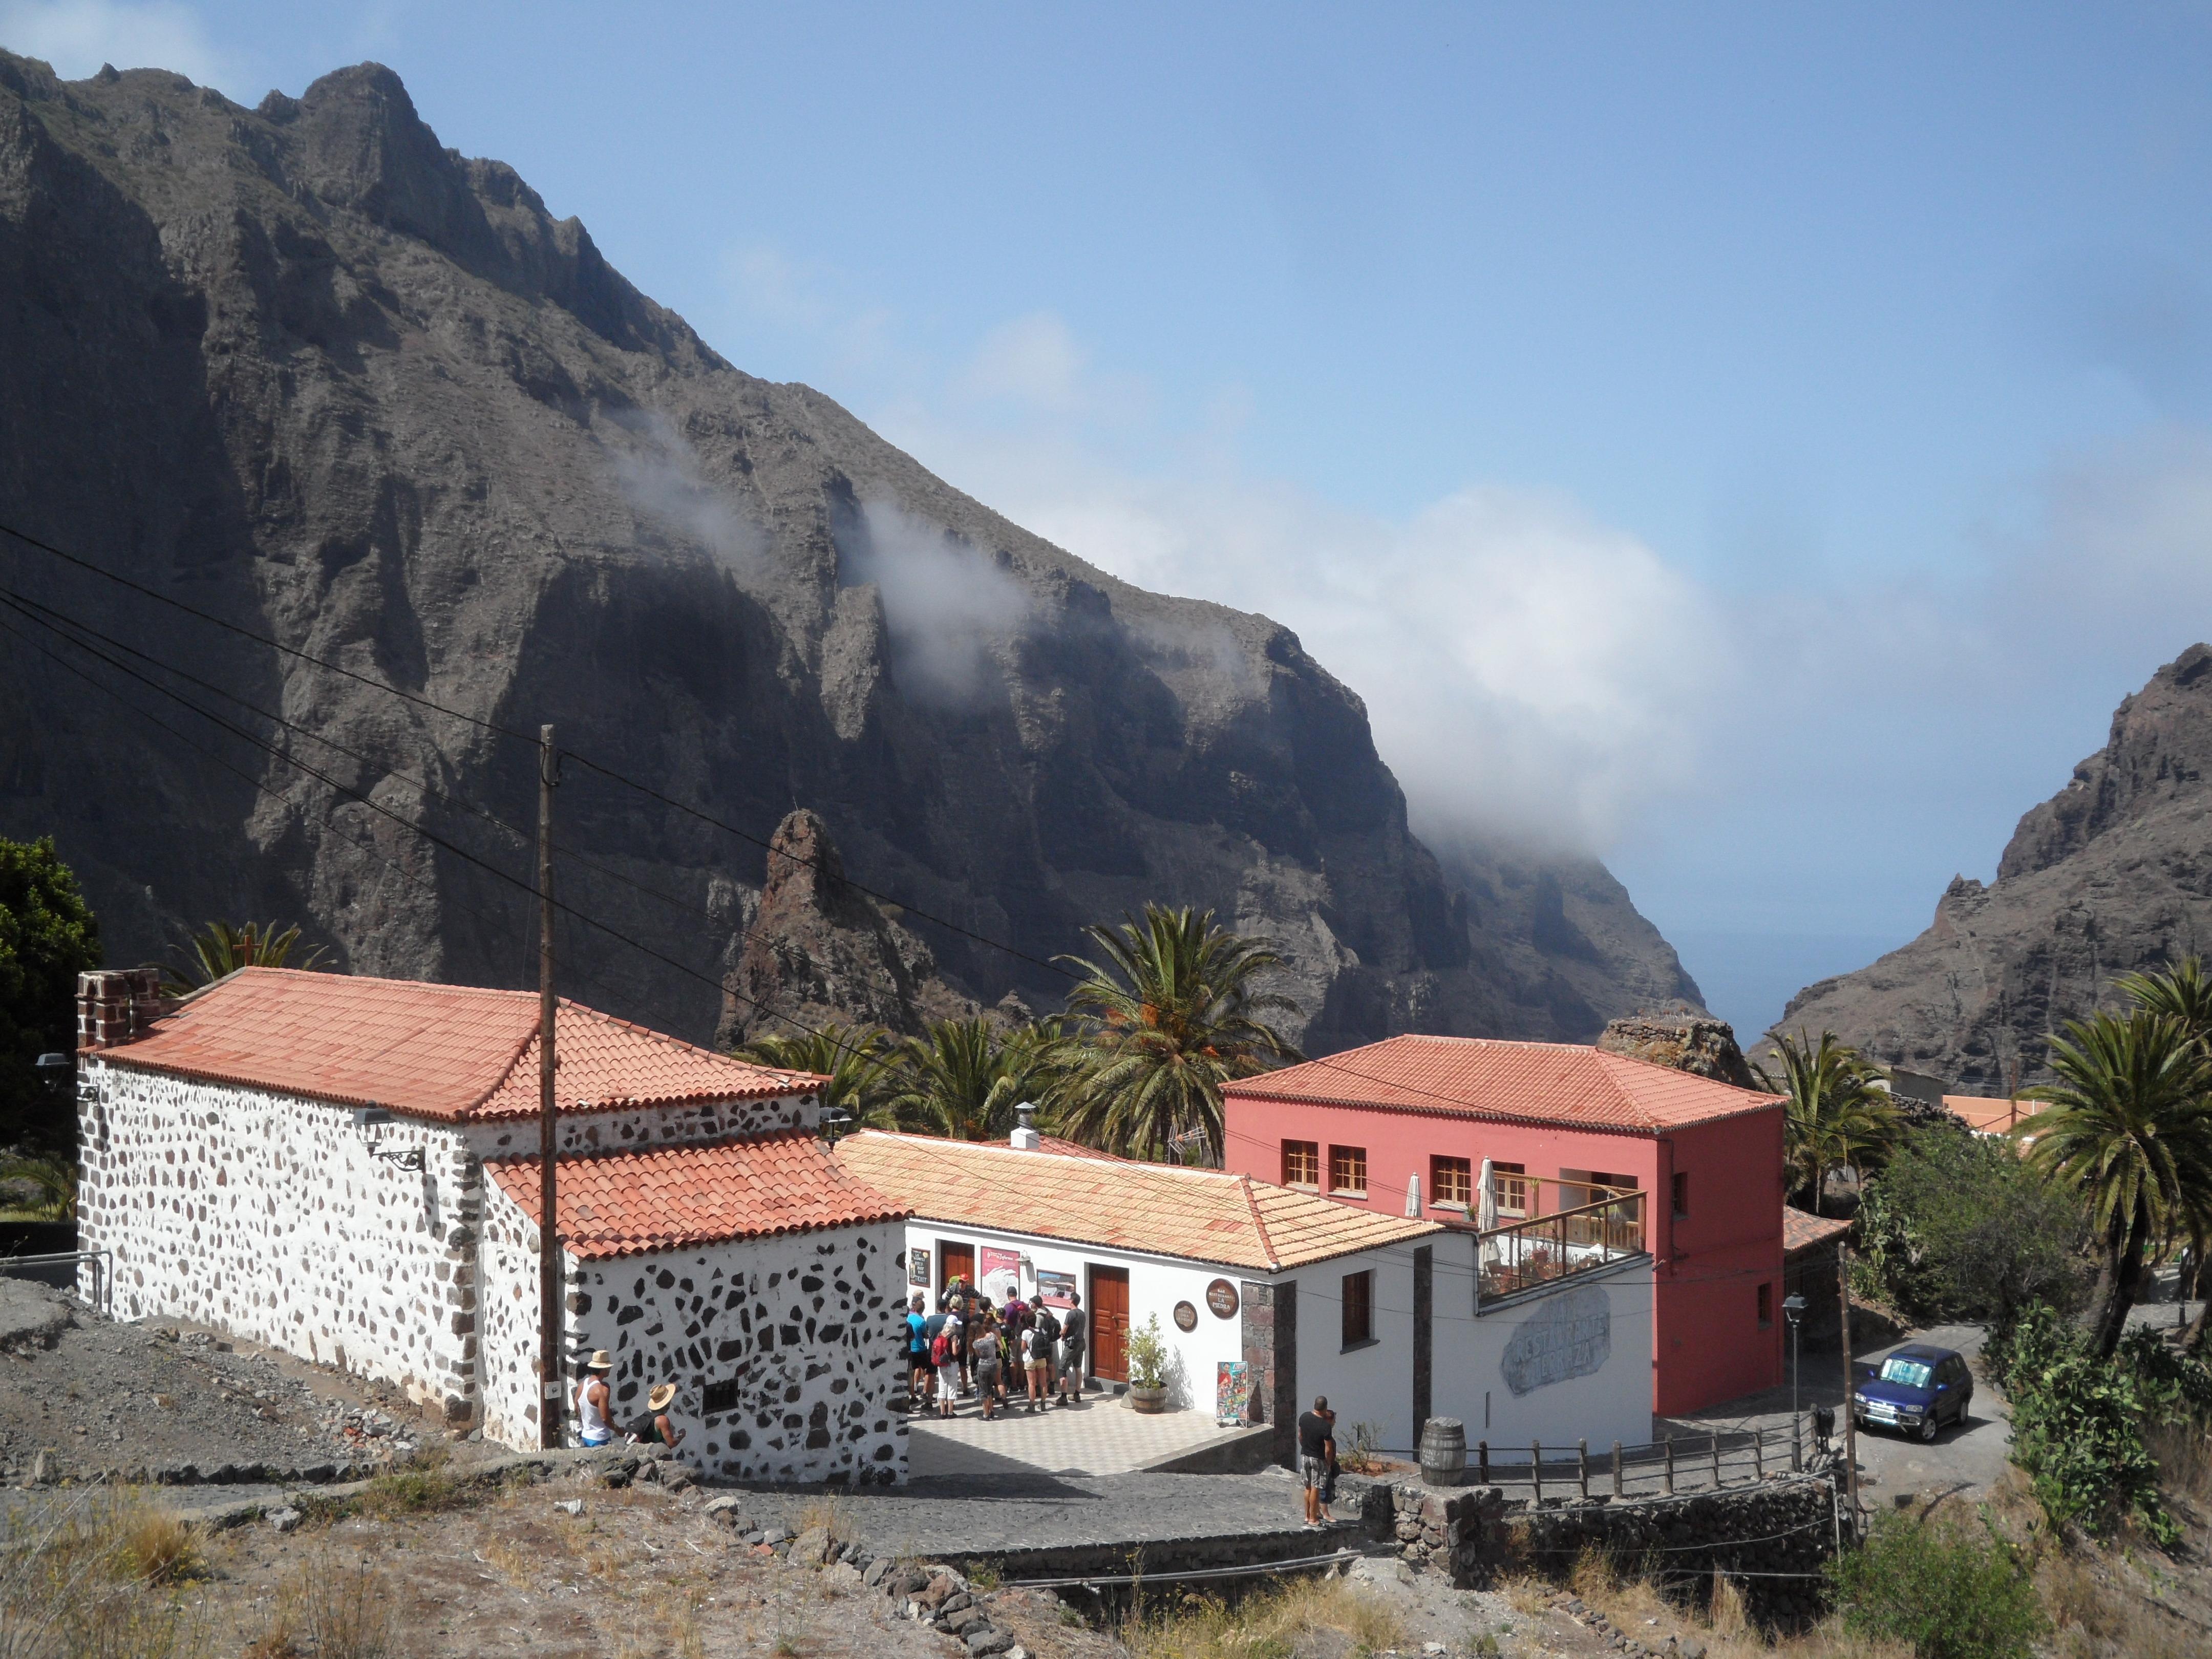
[0,1279,442,1486]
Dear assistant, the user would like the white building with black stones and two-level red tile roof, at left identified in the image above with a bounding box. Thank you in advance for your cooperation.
[77,969,905,1482]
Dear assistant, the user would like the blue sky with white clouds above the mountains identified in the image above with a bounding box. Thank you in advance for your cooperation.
[13,0,2212,1031]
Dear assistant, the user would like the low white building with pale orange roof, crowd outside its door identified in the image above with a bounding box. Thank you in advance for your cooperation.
[836,1131,1652,1458]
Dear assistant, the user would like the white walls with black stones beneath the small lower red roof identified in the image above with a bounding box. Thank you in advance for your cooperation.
[482,1183,907,1484]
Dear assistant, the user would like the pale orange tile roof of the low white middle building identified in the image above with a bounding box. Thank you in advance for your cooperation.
[836,1131,1442,1272]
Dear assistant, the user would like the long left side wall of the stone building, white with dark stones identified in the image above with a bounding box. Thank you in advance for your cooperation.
[77,1055,482,1420]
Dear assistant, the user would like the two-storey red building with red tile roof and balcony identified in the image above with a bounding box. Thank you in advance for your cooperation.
[1223,1037,1785,1416]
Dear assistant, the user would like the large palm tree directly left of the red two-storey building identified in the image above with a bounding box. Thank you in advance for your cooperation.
[1059,905,1303,1168]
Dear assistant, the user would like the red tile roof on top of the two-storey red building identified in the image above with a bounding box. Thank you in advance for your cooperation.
[1221,1037,1783,1135]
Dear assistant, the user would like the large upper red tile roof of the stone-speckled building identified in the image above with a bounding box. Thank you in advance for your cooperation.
[97,969,823,1121]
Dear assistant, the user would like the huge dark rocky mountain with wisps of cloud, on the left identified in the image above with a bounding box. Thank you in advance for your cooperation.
[0,55,1696,1053]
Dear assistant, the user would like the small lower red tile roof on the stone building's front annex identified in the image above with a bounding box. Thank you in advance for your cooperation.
[484,1131,905,1261]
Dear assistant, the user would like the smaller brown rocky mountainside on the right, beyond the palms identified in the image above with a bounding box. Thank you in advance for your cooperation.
[1776,646,2212,1095]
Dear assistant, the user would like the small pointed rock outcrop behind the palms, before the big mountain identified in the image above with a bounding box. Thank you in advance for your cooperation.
[714,807,975,1049]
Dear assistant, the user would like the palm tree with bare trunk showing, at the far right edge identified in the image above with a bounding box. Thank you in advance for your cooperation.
[2013,1009,2212,1356]
